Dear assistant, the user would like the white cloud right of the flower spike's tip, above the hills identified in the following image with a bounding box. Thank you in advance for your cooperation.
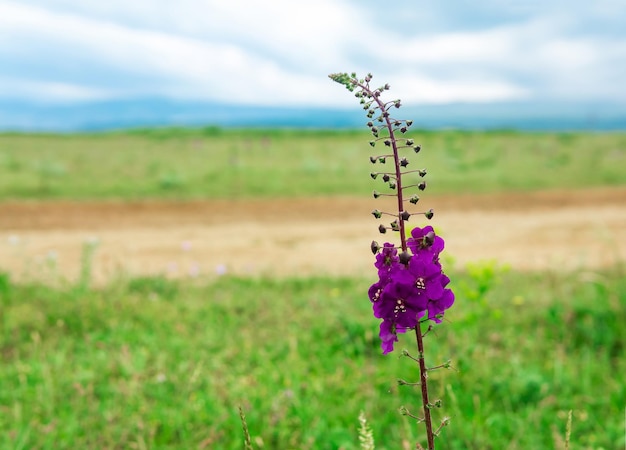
[366,16,626,102]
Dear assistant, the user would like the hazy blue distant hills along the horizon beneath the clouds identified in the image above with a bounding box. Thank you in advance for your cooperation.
[0,99,626,132]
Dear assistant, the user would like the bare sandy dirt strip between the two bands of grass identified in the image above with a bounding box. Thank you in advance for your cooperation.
[0,188,626,281]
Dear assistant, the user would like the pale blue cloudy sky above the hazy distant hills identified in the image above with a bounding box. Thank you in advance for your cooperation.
[0,0,626,107]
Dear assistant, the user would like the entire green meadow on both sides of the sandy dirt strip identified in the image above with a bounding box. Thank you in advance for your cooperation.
[0,128,626,450]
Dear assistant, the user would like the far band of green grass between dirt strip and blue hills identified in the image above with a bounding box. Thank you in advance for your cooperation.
[0,128,626,201]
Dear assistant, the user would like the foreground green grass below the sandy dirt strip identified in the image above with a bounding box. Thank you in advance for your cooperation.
[0,267,626,450]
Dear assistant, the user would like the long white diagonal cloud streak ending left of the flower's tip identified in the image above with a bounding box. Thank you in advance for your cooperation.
[0,4,360,104]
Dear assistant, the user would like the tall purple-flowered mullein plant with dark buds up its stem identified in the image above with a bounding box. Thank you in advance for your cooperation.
[329,73,454,450]
